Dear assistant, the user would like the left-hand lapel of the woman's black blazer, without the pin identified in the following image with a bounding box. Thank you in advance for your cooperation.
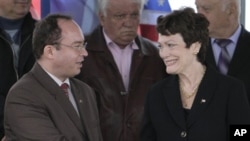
[163,76,186,129]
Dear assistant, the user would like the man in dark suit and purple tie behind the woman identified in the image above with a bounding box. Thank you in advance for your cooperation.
[195,0,250,102]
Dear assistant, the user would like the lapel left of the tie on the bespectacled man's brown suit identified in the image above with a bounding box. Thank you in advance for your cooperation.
[32,63,83,133]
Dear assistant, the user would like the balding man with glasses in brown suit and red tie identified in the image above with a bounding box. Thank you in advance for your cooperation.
[4,15,102,141]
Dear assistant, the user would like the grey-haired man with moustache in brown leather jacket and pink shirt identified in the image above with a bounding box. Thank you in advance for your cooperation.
[75,0,166,141]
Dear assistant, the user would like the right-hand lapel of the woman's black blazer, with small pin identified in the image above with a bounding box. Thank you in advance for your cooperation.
[187,67,218,127]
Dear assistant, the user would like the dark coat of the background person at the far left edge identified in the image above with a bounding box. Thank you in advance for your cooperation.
[0,13,36,139]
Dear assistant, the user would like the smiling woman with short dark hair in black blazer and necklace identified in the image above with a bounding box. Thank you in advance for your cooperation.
[141,8,250,141]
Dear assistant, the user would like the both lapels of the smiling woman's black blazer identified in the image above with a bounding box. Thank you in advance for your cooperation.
[163,67,218,129]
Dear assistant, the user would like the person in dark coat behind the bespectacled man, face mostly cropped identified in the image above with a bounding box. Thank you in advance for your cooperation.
[0,0,36,139]
